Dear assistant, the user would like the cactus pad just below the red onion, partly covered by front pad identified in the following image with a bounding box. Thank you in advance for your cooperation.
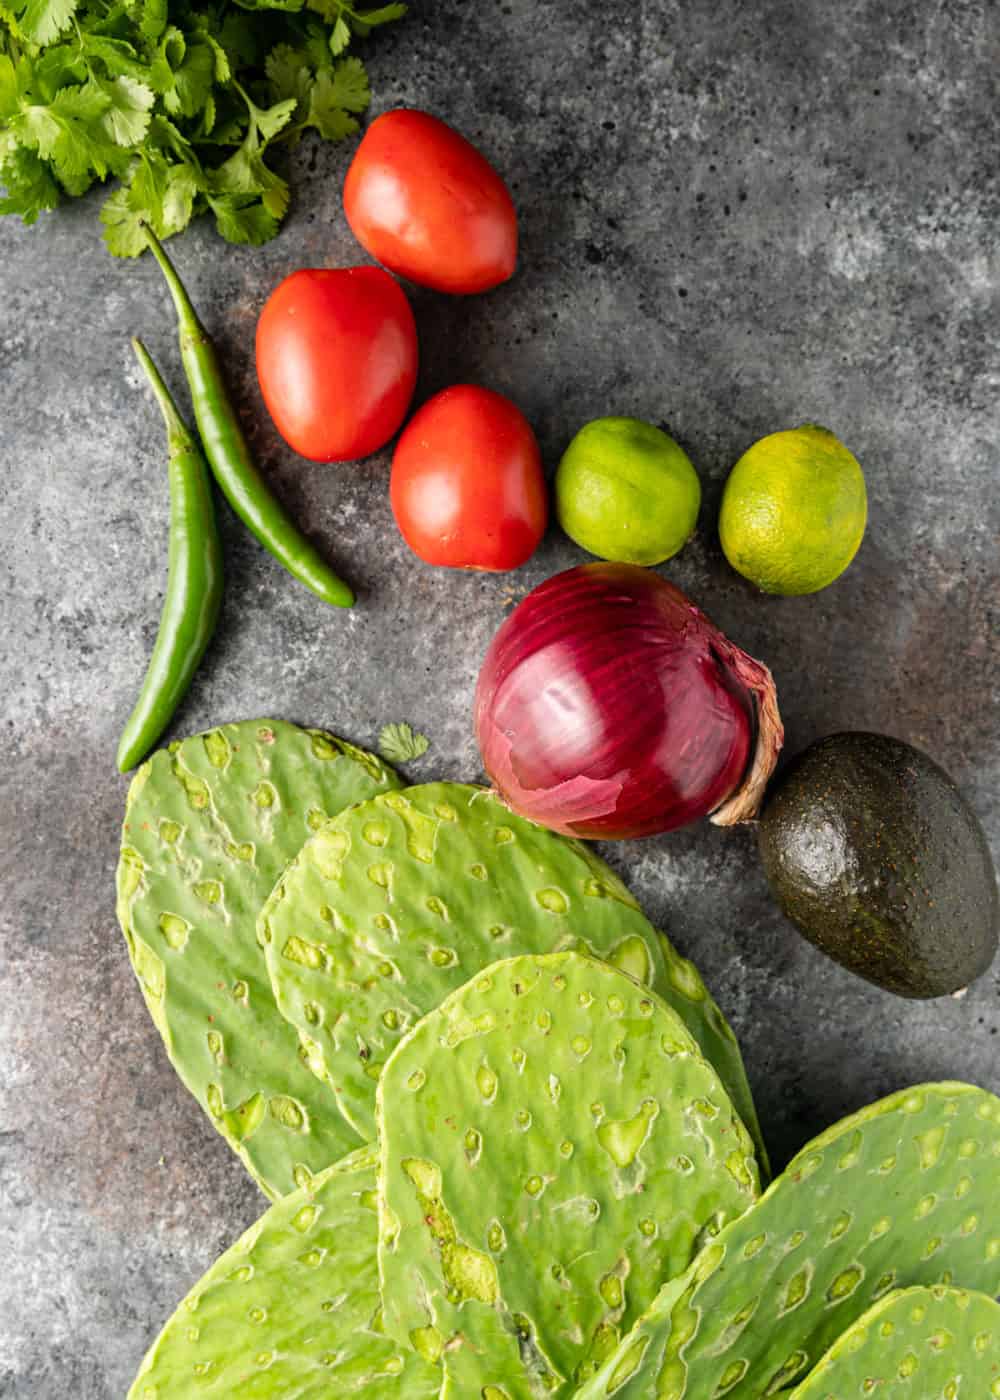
[258,783,759,1159]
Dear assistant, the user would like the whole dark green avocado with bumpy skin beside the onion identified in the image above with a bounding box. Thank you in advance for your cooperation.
[758,732,1000,997]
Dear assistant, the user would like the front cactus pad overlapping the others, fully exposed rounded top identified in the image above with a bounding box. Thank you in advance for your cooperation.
[378,952,758,1400]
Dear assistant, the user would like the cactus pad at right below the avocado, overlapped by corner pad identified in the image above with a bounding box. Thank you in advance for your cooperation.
[580,1084,1000,1400]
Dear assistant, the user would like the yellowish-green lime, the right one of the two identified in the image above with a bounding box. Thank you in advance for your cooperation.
[718,423,868,595]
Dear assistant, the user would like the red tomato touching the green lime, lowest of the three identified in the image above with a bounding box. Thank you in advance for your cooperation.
[389,384,549,573]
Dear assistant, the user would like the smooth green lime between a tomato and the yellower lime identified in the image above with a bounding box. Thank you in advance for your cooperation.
[556,419,702,564]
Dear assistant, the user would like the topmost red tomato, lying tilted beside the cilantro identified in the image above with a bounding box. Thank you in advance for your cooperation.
[343,109,517,293]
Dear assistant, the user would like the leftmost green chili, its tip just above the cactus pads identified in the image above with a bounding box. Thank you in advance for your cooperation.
[118,340,223,773]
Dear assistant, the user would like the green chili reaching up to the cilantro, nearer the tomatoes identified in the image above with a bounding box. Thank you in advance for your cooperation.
[146,228,354,608]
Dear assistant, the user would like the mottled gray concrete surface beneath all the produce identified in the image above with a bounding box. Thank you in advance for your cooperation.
[0,0,1000,1400]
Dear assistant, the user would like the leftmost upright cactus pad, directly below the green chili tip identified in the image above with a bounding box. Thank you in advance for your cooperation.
[118,720,399,1198]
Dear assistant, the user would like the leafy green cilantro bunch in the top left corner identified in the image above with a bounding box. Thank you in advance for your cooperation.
[0,0,406,258]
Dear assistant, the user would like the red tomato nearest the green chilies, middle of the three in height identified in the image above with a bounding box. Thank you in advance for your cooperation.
[256,267,417,462]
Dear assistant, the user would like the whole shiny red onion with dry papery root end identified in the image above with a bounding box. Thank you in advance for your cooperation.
[475,564,784,839]
